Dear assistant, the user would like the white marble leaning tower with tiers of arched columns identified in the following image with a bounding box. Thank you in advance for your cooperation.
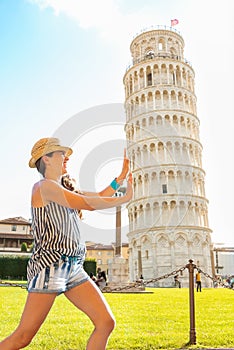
[123,26,212,287]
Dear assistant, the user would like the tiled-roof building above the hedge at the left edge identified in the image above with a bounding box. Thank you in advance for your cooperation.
[0,216,33,252]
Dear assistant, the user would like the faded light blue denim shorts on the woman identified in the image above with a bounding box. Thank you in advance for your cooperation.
[28,256,90,294]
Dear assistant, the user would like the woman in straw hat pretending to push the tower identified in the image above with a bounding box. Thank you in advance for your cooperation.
[0,138,132,350]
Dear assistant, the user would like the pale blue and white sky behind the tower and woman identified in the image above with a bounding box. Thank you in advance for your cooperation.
[0,0,234,246]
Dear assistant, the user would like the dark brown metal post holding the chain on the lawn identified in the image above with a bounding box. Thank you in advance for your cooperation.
[186,259,196,345]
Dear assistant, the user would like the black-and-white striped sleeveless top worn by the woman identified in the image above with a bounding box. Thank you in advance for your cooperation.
[27,202,86,282]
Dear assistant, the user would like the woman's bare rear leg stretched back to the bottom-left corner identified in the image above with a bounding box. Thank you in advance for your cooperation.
[0,293,57,350]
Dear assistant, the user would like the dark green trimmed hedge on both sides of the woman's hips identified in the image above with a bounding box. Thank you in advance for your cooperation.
[0,255,96,280]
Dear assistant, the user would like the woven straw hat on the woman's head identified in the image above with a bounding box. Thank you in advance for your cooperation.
[28,137,72,168]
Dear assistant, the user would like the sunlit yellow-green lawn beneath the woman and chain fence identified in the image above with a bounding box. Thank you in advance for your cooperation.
[0,287,234,350]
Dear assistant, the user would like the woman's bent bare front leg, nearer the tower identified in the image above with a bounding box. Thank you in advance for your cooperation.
[65,281,115,350]
